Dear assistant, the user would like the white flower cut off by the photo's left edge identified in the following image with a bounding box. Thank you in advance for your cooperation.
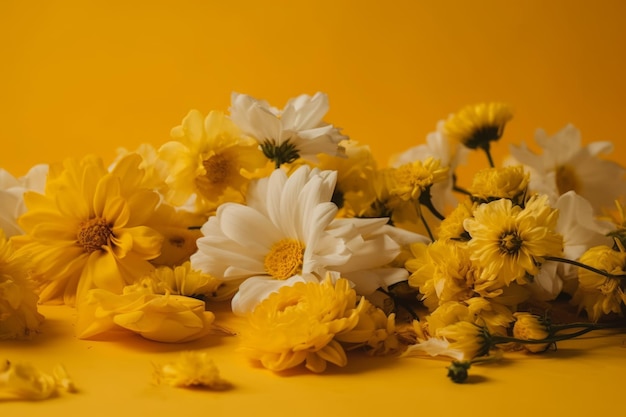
[0,165,48,237]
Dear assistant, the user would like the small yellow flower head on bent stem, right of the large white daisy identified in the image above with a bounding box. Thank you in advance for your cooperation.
[389,157,448,201]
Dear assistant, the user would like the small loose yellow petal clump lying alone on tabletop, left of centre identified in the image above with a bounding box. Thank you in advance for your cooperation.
[154,351,231,390]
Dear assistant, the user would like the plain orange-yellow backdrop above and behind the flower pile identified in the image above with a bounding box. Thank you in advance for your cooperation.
[0,0,626,175]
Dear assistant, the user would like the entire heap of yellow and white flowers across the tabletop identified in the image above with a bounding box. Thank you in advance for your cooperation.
[0,93,626,386]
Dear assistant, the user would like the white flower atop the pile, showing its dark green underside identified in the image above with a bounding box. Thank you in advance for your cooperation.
[230,93,347,166]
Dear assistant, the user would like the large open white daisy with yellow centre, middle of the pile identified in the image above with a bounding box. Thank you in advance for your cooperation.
[191,166,400,314]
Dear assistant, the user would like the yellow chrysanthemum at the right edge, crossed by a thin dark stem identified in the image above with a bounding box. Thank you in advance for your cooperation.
[572,246,626,321]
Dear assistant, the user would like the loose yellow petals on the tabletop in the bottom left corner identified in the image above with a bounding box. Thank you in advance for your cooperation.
[0,360,76,401]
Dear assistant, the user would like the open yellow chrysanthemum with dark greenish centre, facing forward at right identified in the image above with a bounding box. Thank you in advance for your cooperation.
[464,196,563,285]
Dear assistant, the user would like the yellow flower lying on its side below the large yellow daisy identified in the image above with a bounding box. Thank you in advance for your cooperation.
[76,283,215,343]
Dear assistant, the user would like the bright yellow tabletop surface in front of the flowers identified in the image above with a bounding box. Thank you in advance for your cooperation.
[0,306,626,417]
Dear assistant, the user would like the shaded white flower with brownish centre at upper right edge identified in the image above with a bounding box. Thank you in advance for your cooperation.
[510,125,626,214]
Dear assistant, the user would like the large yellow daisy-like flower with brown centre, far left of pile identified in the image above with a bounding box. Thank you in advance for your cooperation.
[16,154,163,304]
